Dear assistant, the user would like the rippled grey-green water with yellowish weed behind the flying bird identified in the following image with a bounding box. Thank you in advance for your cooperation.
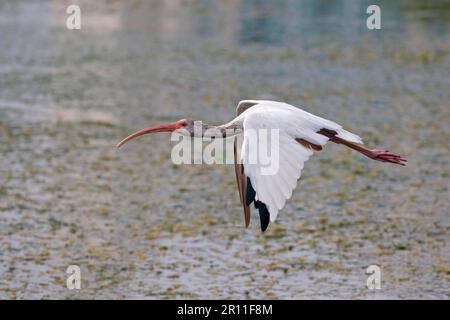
[0,0,450,299]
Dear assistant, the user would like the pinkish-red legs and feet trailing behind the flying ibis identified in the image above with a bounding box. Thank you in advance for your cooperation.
[318,129,407,166]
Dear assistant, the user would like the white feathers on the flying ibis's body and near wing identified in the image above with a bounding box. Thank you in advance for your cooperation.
[236,100,362,222]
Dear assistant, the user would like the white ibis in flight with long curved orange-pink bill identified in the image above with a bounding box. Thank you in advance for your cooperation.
[117,100,406,232]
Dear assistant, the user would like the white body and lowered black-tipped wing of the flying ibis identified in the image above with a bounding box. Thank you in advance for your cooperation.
[235,100,362,231]
